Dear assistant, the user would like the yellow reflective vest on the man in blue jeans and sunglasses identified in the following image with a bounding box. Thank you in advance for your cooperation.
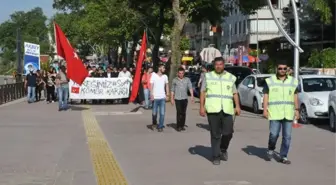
[266,75,298,120]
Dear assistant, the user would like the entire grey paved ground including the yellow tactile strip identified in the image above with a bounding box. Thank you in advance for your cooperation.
[0,102,336,185]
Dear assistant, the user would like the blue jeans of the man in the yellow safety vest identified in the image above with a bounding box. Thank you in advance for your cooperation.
[268,120,293,157]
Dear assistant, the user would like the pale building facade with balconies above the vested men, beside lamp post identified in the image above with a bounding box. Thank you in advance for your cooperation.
[220,0,290,52]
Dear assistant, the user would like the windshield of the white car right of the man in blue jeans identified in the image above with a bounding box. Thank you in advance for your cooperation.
[302,78,336,92]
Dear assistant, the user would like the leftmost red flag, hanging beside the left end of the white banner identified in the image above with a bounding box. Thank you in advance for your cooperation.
[54,23,88,85]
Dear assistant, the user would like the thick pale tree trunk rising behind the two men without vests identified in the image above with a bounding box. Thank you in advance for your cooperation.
[169,0,187,82]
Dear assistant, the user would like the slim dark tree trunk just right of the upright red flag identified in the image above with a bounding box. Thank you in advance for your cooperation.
[152,1,167,71]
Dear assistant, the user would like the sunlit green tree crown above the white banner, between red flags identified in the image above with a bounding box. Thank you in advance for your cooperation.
[54,0,143,65]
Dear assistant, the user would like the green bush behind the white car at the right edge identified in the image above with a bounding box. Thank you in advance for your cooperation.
[308,48,336,68]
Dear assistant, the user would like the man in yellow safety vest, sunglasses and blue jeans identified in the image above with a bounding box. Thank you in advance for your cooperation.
[263,63,299,164]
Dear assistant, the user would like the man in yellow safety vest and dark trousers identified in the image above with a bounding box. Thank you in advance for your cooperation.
[200,57,240,165]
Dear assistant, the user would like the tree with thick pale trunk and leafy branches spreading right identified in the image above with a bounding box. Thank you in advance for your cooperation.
[170,0,264,80]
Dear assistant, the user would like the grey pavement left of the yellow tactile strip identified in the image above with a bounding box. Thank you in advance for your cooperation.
[0,102,96,185]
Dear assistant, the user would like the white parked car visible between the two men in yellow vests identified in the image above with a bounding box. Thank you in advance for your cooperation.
[237,74,272,113]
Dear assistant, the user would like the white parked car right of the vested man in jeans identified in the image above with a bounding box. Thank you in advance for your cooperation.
[298,75,336,124]
